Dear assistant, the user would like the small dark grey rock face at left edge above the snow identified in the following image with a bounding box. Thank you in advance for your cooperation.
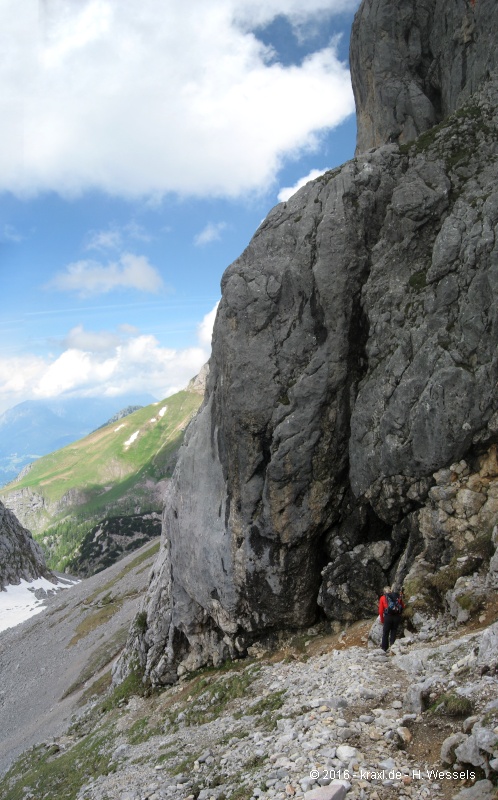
[0,503,50,590]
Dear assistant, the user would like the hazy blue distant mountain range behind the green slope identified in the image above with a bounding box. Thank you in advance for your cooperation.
[0,394,155,486]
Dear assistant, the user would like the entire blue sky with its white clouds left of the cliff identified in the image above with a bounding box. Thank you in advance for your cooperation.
[0,0,359,413]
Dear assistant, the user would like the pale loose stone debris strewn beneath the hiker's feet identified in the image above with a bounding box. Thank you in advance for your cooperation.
[49,619,498,800]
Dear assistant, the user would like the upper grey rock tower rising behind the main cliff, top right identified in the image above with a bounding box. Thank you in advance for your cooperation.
[351,0,498,153]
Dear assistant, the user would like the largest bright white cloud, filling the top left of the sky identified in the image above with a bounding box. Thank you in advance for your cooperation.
[0,0,359,197]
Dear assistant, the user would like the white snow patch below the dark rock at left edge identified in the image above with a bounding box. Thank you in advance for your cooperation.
[0,578,80,632]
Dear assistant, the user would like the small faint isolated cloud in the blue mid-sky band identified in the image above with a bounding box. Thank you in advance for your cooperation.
[47,253,163,297]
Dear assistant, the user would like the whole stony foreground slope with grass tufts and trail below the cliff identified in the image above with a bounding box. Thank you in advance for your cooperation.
[0,580,498,800]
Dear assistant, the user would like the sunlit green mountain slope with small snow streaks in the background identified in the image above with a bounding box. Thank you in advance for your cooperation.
[0,391,202,570]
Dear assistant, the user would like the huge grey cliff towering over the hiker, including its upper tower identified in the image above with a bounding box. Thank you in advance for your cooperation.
[118,0,498,683]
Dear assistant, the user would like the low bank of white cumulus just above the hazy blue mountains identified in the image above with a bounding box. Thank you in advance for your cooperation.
[0,305,218,412]
